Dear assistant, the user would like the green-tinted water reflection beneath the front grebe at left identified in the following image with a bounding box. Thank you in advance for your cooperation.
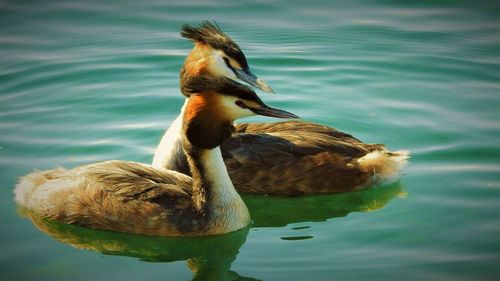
[20,208,253,281]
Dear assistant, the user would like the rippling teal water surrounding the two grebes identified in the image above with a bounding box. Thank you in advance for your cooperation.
[0,0,500,280]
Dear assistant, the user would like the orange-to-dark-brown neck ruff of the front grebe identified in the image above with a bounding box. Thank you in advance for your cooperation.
[183,93,232,149]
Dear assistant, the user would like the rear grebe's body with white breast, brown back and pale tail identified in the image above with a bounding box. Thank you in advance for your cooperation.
[152,114,408,196]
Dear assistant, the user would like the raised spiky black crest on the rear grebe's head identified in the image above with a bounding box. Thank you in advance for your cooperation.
[181,20,248,69]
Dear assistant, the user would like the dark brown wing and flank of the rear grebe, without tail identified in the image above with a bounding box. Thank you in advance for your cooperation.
[222,121,378,195]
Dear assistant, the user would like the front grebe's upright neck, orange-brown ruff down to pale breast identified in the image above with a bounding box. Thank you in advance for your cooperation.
[183,96,250,232]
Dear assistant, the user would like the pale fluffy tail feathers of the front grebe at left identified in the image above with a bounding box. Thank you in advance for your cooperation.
[14,168,66,207]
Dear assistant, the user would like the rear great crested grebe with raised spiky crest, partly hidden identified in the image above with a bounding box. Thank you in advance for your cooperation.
[152,22,409,196]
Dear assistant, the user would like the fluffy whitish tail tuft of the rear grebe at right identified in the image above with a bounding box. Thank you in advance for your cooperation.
[358,150,410,183]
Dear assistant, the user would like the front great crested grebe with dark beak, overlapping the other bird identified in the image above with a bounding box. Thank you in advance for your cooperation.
[15,76,297,236]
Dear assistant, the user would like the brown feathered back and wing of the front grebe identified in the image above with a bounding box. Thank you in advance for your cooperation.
[42,161,196,235]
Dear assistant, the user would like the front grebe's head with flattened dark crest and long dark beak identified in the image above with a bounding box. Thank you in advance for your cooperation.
[183,75,299,148]
